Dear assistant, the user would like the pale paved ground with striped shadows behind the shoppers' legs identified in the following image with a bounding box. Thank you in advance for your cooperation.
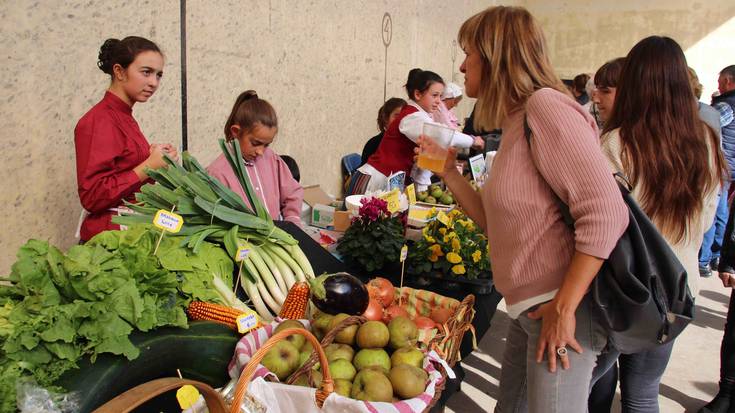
[446,275,730,413]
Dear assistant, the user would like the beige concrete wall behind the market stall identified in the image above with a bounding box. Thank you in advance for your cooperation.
[0,0,735,274]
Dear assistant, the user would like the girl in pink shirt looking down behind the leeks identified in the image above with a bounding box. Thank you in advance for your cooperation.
[207,90,304,226]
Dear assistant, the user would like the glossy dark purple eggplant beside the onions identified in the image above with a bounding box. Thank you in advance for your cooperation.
[309,272,370,315]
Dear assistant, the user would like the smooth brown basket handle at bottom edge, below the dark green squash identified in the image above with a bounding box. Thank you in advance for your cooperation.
[94,377,227,413]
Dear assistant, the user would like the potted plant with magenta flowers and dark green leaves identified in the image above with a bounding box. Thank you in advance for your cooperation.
[337,197,405,273]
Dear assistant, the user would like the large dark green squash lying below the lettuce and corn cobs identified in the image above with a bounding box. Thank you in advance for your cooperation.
[57,321,240,412]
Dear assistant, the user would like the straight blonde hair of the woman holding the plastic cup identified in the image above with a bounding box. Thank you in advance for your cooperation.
[457,6,569,130]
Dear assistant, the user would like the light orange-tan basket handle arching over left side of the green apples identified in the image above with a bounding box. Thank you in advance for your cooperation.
[230,328,334,413]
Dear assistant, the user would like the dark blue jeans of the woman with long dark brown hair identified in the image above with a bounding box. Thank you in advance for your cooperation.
[591,342,674,413]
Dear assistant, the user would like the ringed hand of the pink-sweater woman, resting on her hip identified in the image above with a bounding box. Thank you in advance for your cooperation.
[528,301,582,373]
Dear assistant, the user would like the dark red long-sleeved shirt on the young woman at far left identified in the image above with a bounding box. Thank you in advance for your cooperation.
[74,92,150,241]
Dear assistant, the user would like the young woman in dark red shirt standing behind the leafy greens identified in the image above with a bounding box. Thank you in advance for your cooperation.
[74,36,178,242]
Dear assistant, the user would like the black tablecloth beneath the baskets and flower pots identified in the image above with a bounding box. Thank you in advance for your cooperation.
[276,221,502,411]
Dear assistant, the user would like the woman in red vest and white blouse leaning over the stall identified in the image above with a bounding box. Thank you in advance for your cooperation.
[345,69,475,196]
